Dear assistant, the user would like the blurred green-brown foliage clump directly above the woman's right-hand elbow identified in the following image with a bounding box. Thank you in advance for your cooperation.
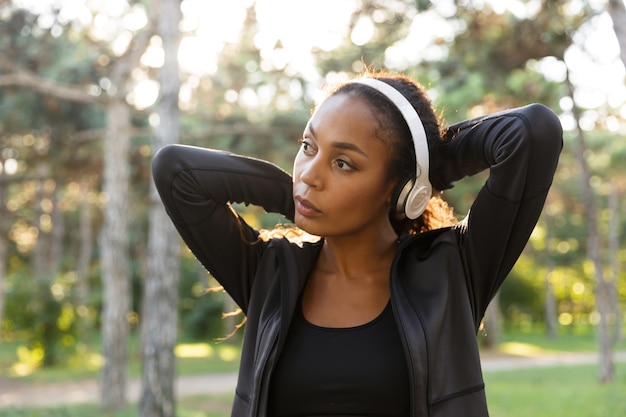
[429,2,578,115]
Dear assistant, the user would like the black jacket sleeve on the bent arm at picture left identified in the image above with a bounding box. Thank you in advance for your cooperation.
[152,145,294,312]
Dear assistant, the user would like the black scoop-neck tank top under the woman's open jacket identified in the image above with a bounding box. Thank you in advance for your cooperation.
[268,303,410,417]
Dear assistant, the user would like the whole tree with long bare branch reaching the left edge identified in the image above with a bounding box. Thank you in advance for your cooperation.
[0,1,150,408]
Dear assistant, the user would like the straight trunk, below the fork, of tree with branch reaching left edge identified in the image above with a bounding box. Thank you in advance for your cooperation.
[100,100,131,409]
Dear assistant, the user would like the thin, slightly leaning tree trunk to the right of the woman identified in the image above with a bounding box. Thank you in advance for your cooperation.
[567,74,615,383]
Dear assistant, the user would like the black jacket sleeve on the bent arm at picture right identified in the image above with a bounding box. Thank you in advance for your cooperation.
[445,104,563,323]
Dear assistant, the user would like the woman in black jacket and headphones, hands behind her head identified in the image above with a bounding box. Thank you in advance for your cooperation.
[153,73,562,417]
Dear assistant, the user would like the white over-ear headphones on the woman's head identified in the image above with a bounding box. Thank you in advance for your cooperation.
[350,78,432,220]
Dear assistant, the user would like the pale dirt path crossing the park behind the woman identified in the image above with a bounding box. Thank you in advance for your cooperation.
[0,352,626,410]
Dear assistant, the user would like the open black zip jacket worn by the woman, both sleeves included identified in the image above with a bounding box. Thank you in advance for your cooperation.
[153,101,562,417]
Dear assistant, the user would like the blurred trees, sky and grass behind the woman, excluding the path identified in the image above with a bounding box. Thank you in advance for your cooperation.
[0,0,626,417]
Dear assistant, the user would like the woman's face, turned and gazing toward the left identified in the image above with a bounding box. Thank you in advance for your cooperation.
[293,93,393,238]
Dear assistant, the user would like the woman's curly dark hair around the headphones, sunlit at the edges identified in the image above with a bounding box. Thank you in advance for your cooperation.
[328,70,457,235]
